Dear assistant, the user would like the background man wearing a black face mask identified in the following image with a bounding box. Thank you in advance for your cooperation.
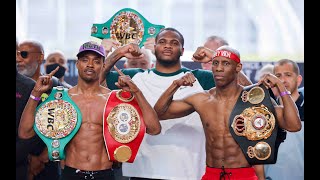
[43,50,72,89]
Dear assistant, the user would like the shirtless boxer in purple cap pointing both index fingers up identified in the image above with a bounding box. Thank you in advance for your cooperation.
[19,42,161,180]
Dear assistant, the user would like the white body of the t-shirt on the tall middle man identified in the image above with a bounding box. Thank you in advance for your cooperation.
[106,70,213,180]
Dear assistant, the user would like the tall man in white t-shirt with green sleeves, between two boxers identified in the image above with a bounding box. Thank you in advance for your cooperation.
[100,28,249,180]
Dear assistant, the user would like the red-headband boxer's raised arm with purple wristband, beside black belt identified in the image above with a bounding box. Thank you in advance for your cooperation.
[259,74,301,132]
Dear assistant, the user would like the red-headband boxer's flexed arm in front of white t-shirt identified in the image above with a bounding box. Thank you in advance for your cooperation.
[154,72,195,120]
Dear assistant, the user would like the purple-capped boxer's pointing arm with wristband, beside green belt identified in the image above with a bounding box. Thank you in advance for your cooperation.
[18,67,59,139]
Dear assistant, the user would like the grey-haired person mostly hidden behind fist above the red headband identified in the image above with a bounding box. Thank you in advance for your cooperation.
[201,36,229,71]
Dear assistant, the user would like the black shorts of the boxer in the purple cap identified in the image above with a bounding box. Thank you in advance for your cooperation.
[61,166,115,180]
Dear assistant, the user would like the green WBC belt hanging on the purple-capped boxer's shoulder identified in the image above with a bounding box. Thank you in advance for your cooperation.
[33,86,82,161]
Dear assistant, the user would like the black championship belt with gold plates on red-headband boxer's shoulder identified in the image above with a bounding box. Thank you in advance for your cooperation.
[229,84,278,165]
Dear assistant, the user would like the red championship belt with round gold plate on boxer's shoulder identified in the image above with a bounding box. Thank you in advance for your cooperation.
[103,90,146,163]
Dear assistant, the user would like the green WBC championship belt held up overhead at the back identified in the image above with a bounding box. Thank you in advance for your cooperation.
[91,8,164,48]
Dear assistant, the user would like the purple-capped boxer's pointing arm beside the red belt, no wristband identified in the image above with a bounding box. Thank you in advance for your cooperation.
[114,66,161,135]
